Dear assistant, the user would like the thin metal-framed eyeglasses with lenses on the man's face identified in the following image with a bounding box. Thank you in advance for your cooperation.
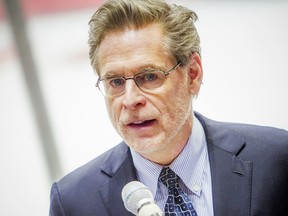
[96,61,182,97]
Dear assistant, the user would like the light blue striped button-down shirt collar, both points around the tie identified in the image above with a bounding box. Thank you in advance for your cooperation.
[131,116,207,197]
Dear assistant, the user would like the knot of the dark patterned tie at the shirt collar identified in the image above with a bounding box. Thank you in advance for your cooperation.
[159,167,180,189]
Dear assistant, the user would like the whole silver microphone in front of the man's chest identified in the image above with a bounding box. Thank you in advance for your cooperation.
[121,181,164,216]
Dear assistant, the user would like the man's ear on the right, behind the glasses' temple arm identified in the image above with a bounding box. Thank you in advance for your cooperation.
[188,52,203,96]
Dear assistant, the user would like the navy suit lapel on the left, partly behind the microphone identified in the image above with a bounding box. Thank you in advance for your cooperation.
[99,143,136,216]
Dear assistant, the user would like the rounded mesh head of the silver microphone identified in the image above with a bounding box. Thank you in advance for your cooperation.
[121,181,154,215]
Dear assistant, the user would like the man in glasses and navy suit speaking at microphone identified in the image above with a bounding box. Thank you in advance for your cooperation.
[50,0,288,216]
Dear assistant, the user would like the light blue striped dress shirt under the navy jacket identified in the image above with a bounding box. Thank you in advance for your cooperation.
[131,116,213,216]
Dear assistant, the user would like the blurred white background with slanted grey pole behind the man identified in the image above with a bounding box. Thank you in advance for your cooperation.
[0,0,288,216]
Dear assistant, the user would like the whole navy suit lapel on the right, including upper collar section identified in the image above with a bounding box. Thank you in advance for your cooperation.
[196,114,253,216]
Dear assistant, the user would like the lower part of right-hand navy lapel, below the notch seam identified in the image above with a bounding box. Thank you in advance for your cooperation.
[208,145,252,216]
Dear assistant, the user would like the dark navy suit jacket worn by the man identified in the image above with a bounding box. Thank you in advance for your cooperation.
[50,113,288,216]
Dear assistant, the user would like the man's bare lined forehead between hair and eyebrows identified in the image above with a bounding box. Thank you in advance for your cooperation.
[98,24,171,76]
